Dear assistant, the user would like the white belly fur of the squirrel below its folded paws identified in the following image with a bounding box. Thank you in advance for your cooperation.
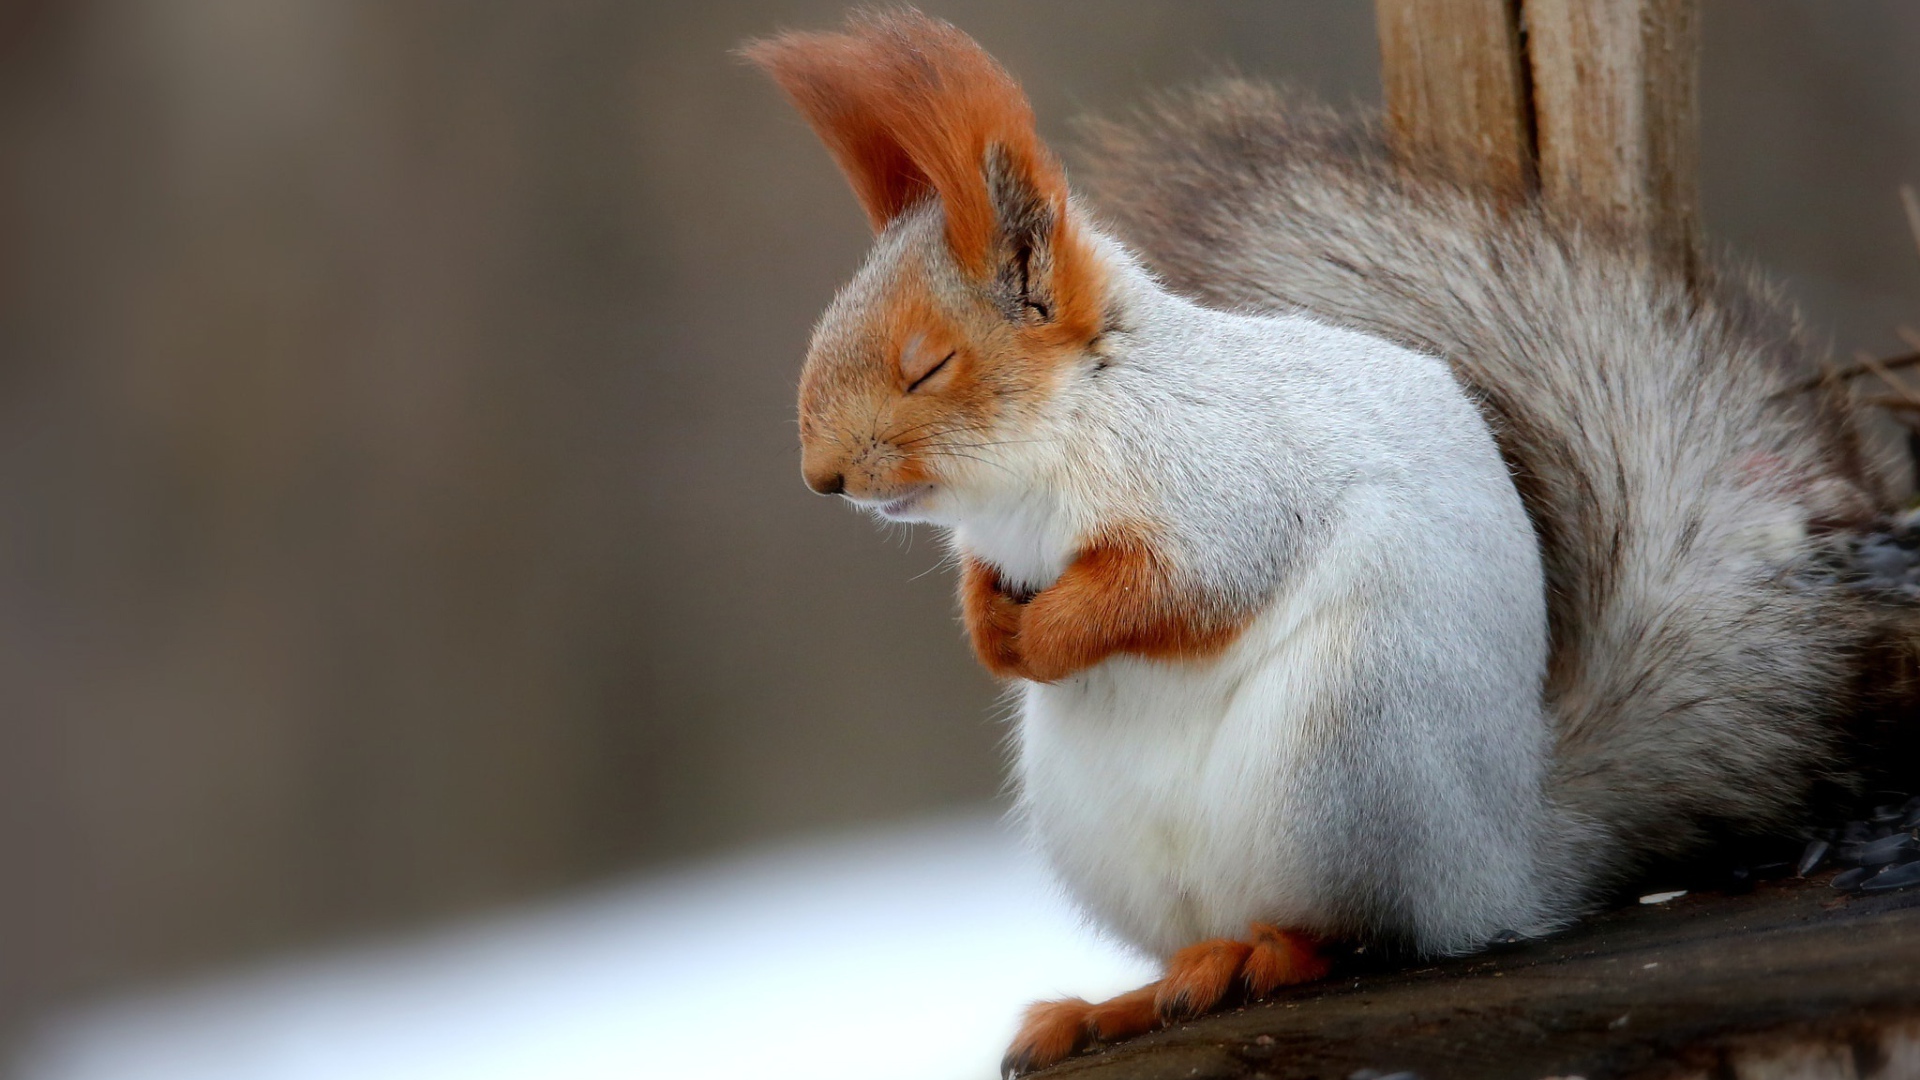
[1018,541,1359,957]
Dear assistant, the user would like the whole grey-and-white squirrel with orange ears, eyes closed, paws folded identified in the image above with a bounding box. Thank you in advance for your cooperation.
[743,10,1920,1074]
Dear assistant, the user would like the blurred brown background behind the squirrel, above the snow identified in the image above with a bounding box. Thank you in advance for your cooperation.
[0,0,1920,1053]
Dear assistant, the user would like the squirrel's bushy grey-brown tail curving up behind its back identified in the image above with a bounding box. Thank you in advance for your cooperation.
[1087,81,1912,894]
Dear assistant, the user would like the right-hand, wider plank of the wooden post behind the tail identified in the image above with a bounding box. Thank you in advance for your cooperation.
[1521,0,1699,275]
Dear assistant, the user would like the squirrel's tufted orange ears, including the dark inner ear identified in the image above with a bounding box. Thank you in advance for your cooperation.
[741,10,1100,338]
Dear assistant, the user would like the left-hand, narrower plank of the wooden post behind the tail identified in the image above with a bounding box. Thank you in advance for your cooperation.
[1375,0,1534,196]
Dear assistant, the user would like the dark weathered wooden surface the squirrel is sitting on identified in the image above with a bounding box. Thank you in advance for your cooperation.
[1035,874,1920,1080]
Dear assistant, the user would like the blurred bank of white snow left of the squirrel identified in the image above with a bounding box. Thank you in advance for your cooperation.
[15,815,1154,1080]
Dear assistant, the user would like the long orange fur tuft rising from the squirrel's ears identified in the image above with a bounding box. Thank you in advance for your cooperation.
[741,10,1068,273]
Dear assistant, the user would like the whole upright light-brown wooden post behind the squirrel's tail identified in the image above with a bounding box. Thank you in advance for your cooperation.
[1375,0,1699,279]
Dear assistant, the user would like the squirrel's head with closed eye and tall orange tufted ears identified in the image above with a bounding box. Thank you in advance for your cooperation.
[743,10,1106,521]
